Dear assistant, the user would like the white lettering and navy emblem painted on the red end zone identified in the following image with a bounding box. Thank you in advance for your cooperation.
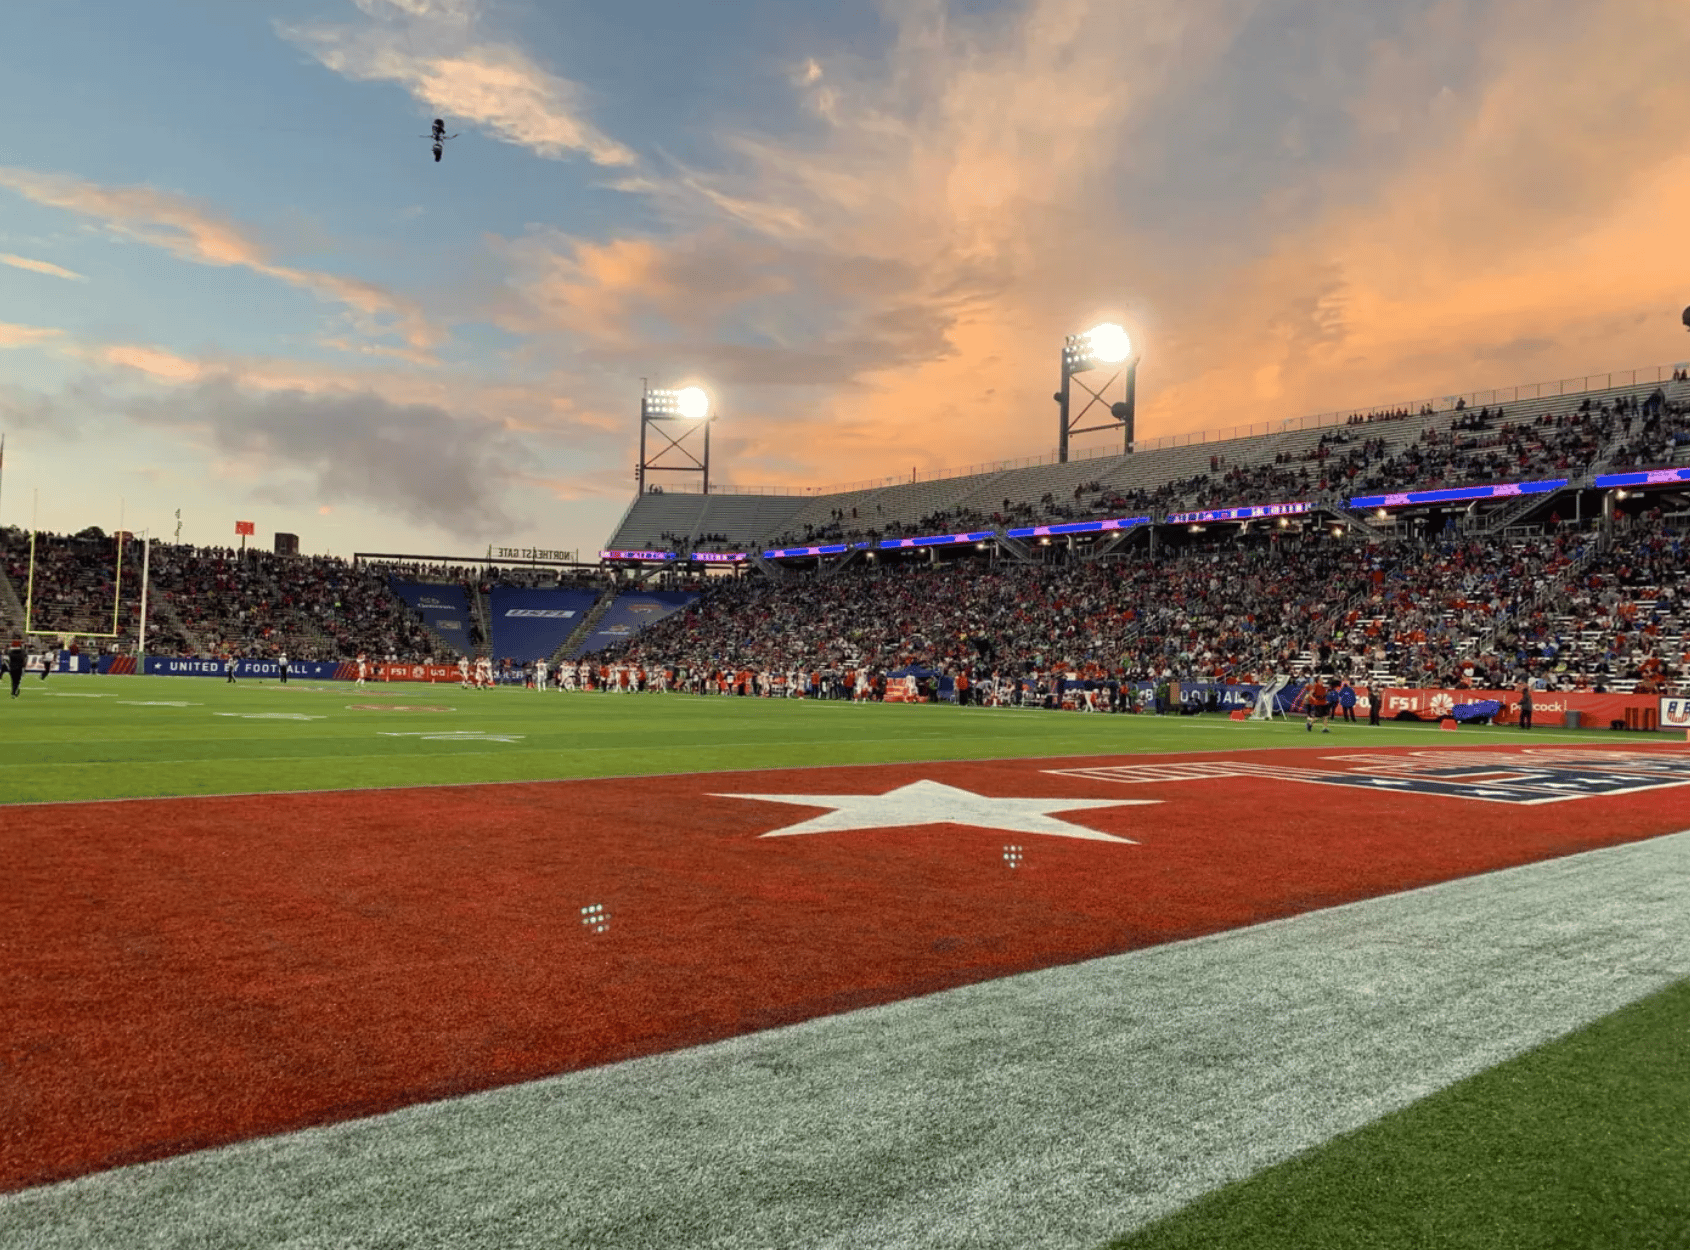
[1048,746,1690,806]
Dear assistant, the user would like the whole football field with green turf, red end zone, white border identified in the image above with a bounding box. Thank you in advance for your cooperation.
[0,676,1690,1250]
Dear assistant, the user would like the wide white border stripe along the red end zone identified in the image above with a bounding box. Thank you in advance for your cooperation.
[0,833,1690,1250]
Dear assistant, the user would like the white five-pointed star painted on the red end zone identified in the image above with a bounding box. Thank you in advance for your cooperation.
[711,780,1159,843]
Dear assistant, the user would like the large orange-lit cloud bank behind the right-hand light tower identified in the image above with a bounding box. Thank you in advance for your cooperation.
[510,0,1690,485]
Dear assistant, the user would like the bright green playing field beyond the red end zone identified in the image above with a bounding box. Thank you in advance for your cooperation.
[0,674,1642,802]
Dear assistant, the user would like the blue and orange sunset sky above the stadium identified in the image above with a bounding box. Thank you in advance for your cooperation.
[0,0,1690,554]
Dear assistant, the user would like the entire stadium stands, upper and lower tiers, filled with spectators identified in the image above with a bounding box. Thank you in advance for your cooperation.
[0,363,1690,689]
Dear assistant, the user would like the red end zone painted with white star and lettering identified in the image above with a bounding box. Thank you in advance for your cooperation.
[0,743,1690,1189]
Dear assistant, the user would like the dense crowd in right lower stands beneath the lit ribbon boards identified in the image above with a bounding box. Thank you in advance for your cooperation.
[607,530,1690,702]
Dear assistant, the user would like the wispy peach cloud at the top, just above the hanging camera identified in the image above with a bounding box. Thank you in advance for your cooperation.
[277,0,637,166]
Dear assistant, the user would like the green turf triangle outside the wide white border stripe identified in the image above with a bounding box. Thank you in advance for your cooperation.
[1114,981,1690,1250]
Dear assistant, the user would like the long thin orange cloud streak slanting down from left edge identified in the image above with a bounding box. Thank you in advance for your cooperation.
[0,167,444,350]
